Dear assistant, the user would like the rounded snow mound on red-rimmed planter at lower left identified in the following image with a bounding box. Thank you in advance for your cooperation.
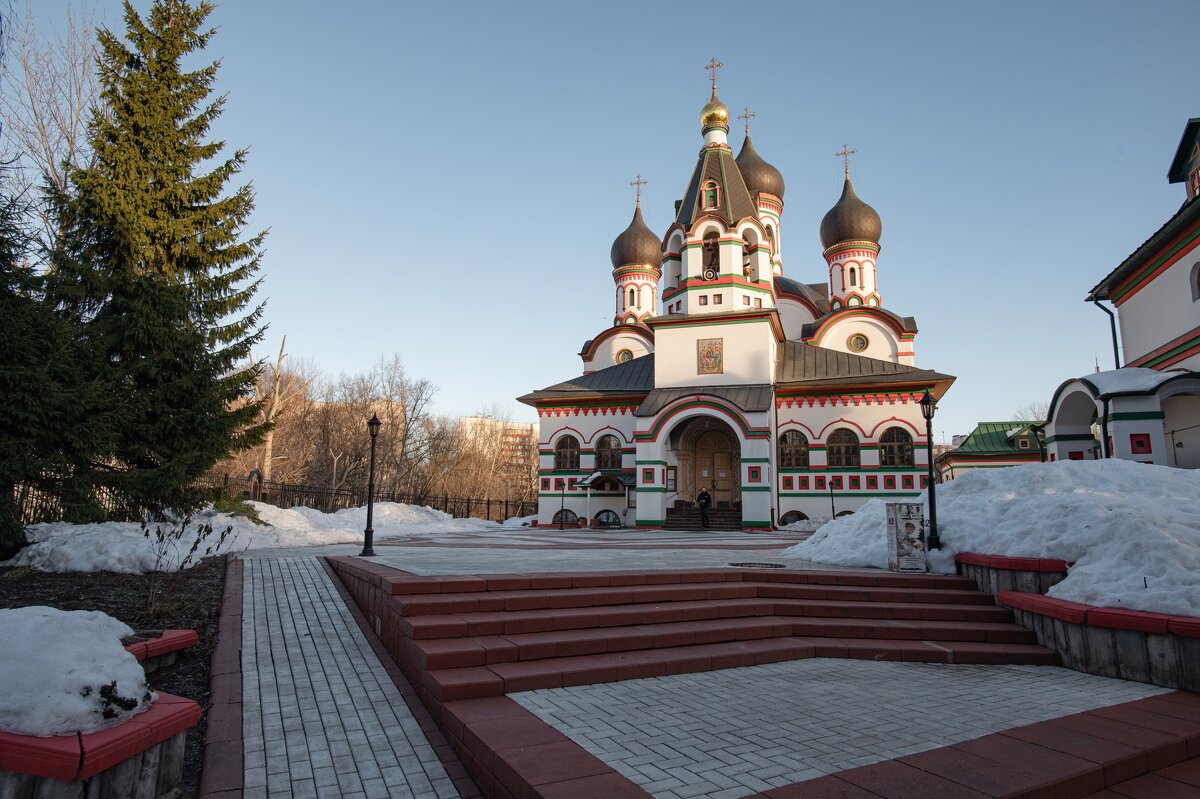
[0,607,151,738]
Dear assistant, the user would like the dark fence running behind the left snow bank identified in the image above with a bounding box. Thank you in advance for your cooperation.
[13,476,538,527]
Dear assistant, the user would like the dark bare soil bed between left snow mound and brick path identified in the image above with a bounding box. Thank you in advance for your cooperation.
[0,557,226,798]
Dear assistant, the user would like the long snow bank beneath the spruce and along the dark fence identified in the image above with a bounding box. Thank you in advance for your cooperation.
[4,503,500,575]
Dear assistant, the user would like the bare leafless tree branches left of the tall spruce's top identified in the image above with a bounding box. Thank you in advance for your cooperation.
[0,0,98,233]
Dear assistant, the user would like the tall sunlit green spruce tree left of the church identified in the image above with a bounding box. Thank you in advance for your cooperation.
[50,0,265,509]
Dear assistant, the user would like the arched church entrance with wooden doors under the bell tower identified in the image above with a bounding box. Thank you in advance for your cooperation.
[671,416,742,509]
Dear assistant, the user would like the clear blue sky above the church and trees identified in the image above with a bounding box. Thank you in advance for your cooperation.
[35,0,1200,439]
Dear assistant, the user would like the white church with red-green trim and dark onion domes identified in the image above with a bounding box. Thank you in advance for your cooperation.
[520,66,954,530]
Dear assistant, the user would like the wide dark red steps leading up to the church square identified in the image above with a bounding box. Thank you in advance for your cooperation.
[380,569,1058,702]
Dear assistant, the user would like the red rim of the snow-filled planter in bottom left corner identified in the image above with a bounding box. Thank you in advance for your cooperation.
[0,693,200,782]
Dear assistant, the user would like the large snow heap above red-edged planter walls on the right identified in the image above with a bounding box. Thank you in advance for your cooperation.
[785,459,1200,617]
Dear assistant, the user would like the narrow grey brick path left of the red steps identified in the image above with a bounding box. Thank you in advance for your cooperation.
[242,555,458,799]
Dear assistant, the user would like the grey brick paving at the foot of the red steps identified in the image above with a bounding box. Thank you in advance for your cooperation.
[509,659,1169,799]
